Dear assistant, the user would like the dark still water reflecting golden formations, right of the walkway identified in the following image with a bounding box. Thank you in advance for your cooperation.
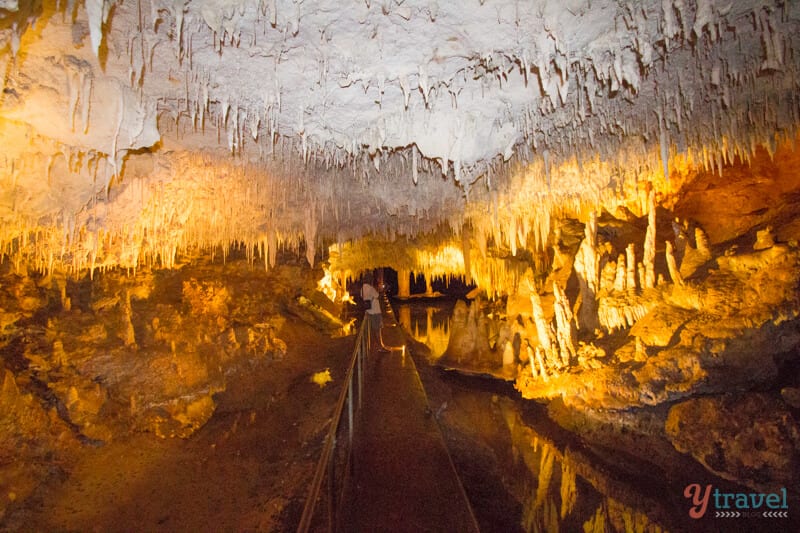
[397,302,717,533]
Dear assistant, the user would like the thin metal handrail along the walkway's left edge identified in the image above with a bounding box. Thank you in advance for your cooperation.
[297,310,370,533]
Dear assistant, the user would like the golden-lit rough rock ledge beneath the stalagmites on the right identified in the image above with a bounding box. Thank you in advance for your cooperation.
[517,233,800,408]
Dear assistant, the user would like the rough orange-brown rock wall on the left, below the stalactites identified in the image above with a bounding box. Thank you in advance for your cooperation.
[0,254,350,521]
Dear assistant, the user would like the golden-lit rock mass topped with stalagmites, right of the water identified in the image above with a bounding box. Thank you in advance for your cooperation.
[428,139,800,490]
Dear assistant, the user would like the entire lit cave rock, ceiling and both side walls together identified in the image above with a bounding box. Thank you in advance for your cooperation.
[0,0,800,529]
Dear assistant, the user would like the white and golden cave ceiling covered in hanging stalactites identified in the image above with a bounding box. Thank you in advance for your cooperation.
[0,0,800,272]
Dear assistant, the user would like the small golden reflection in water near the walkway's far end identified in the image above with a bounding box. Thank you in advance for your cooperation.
[395,301,455,361]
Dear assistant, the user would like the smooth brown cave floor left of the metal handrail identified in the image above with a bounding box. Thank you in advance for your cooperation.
[6,321,353,531]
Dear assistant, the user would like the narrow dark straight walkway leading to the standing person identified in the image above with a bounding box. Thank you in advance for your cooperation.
[338,298,479,532]
